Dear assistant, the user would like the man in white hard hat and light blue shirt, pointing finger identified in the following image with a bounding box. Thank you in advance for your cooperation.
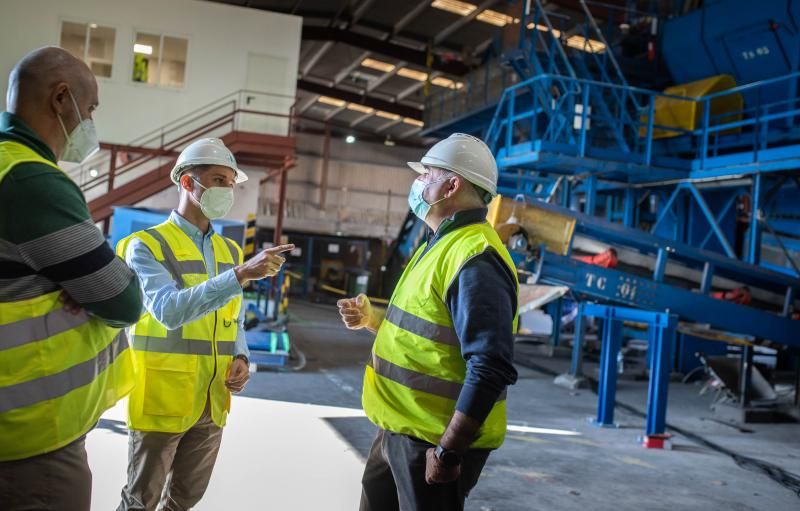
[117,138,294,511]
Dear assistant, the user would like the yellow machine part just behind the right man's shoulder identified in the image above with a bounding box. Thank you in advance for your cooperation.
[486,195,575,255]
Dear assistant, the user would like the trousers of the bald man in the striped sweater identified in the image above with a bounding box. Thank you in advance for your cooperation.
[0,437,92,511]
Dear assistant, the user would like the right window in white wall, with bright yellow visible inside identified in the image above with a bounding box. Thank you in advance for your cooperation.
[132,32,189,87]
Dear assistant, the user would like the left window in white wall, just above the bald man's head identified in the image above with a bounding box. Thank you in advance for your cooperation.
[61,21,116,78]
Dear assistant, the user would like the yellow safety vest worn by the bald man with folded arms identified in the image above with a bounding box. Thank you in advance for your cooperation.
[0,142,134,461]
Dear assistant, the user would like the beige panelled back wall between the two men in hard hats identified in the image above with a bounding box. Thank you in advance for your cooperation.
[257,134,424,239]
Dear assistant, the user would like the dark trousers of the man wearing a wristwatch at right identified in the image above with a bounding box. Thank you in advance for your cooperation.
[360,430,491,511]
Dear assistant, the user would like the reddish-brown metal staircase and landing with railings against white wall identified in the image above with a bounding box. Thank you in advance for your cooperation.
[68,90,295,229]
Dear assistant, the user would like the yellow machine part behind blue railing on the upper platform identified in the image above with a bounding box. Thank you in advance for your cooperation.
[639,75,744,139]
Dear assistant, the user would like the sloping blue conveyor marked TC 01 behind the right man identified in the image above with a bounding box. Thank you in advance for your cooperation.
[506,203,800,347]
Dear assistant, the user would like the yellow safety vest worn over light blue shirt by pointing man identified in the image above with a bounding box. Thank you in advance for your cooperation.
[117,221,242,433]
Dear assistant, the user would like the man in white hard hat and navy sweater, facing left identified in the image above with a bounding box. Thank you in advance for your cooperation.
[339,133,519,511]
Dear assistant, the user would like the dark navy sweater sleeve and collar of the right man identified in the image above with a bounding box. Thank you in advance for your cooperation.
[420,208,517,422]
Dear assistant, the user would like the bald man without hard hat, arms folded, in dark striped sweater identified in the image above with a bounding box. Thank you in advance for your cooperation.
[0,48,142,511]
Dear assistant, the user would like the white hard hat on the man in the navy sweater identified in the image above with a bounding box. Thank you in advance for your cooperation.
[408,133,497,197]
